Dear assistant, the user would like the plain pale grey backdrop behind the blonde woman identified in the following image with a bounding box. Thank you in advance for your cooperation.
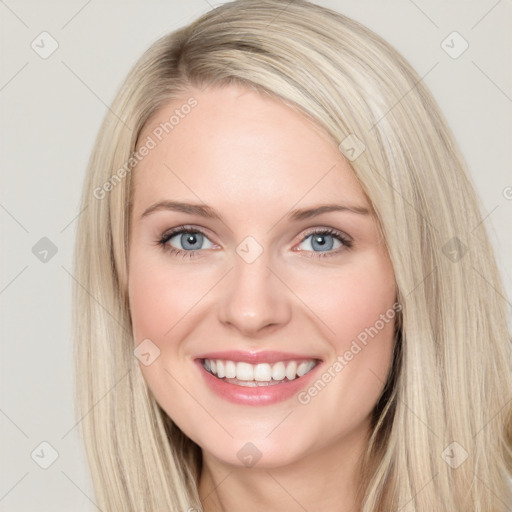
[0,0,512,512]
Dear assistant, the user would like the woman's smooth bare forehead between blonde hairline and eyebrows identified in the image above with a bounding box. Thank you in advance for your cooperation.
[133,86,367,215]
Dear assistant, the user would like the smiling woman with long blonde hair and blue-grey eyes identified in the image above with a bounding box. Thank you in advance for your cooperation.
[74,0,512,512]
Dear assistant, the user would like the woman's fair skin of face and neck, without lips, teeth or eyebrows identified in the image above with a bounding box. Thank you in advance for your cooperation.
[128,86,396,512]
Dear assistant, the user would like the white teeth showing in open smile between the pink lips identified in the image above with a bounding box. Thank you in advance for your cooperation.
[201,359,320,387]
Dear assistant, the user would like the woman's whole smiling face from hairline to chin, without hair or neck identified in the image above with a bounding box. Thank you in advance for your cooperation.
[128,86,397,467]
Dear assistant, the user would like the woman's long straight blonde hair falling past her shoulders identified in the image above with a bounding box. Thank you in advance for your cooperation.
[73,0,512,512]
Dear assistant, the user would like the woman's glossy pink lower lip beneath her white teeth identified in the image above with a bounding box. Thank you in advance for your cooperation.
[195,360,322,405]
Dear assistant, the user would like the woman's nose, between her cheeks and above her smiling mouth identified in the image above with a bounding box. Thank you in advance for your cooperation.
[218,253,292,337]
